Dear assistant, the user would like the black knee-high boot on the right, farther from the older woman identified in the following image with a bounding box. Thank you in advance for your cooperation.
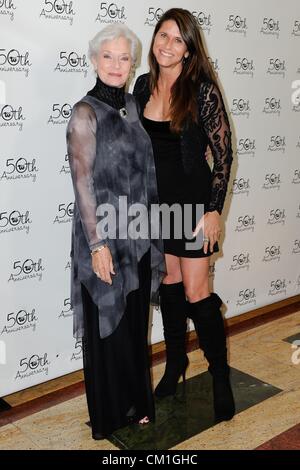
[190,293,235,422]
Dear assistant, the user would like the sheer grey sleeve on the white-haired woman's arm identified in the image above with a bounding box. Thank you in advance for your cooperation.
[67,103,104,250]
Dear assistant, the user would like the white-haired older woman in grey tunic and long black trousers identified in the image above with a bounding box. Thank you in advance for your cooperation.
[67,24,164,439]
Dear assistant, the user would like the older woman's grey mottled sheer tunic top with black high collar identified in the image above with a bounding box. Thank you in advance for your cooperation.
[67,79,165,338]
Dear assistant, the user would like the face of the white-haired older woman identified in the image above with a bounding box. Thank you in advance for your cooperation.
[92,36,132,88]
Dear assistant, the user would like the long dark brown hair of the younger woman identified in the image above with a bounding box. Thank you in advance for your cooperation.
[148,8,216,132]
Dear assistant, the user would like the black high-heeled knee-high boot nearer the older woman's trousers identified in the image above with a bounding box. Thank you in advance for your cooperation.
[154,282,188,398]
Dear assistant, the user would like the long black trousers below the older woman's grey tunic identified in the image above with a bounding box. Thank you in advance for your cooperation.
[82,251,154,439]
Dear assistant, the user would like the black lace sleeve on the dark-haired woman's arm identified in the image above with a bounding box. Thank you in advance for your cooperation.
[199,83,232,214]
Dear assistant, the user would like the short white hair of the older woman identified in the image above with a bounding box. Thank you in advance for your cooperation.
[88,23,140,64]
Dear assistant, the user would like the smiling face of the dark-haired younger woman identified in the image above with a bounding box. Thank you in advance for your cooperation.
[152,20,189,68]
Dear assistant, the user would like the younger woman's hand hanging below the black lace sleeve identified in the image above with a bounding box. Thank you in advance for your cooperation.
[193,211,221,254]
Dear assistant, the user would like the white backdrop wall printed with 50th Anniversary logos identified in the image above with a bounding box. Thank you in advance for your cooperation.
[0,0,300,396]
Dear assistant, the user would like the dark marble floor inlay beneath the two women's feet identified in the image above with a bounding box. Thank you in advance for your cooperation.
[109,368,282,450]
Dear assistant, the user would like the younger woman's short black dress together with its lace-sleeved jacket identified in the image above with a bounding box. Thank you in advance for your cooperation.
[133,74,232,258]
